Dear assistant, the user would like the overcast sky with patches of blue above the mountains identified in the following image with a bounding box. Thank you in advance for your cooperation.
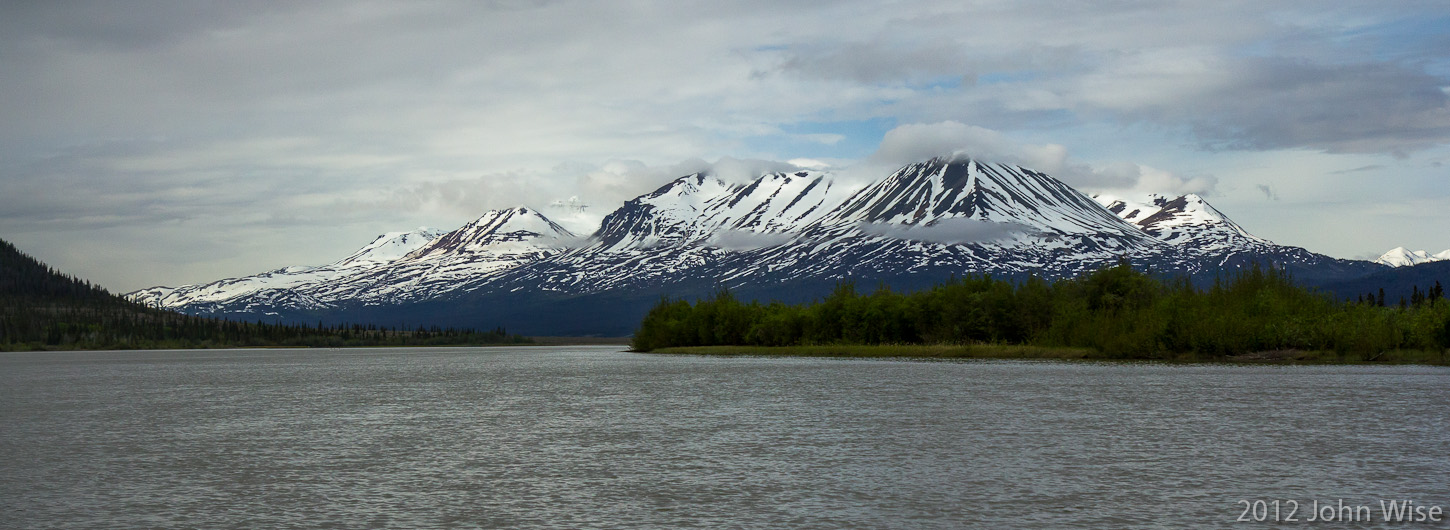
[0,0,1450,293]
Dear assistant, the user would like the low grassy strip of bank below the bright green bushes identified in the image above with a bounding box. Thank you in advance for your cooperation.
[648,345,1450,366]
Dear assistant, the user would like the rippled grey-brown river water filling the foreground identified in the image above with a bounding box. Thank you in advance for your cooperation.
[0,346,1450,529]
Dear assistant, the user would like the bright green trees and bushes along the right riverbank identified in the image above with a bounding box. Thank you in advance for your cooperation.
[632,262,1450,359]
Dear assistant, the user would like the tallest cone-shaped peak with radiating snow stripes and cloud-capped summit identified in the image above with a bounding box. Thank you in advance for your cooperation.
[726,158,1166,282]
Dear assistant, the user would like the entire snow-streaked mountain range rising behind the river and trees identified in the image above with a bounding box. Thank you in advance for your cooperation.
[128,158,1386,335]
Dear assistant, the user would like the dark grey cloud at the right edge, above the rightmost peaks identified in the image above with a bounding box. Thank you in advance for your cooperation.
[1064,52,1450,155]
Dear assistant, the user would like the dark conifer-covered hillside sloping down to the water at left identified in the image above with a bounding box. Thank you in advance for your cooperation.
[0,240,529,350]
